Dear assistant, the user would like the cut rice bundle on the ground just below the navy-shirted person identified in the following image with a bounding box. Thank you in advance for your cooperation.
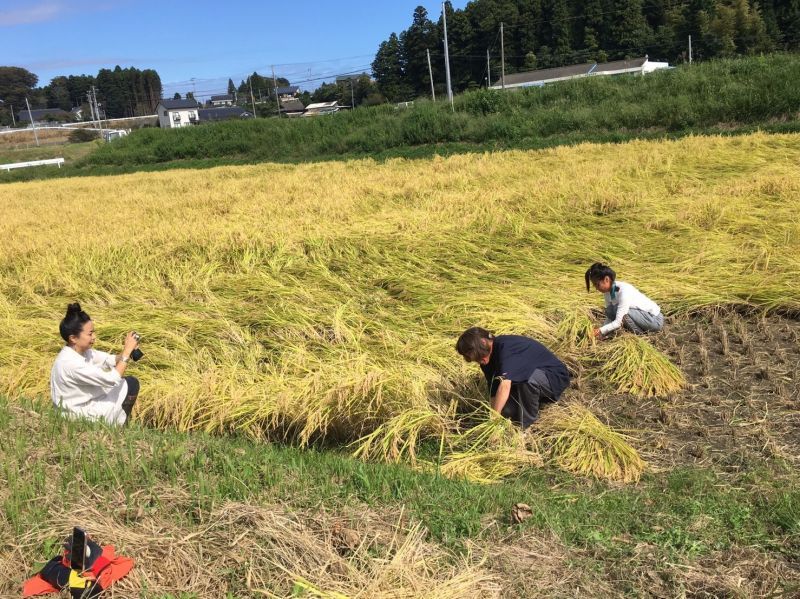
[537,405,646,483]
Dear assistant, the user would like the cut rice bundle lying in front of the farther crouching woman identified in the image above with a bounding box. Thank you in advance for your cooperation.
[593,335,686,397]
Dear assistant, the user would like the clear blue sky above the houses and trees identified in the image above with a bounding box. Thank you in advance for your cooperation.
[0,0,467,99]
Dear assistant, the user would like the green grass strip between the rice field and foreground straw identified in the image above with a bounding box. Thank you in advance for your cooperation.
[0,400,800,559]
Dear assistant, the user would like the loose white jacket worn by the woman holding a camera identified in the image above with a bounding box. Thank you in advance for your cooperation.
[50,346,128,424]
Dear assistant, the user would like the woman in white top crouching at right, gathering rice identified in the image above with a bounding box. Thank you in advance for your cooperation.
[586,262,664,339]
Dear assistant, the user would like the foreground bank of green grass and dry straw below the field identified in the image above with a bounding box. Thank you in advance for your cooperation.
[0,399,800,599]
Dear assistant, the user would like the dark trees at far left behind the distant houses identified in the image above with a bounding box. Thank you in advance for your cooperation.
[0,66,162,125]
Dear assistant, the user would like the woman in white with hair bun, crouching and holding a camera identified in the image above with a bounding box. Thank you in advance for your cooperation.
[50,303,139,424]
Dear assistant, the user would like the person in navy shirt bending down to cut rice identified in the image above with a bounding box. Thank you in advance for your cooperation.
[456,327,569,430]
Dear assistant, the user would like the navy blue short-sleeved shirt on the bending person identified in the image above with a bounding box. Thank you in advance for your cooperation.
[480,335,569,399]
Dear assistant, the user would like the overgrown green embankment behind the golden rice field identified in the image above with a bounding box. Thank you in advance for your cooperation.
[0,55,800,181]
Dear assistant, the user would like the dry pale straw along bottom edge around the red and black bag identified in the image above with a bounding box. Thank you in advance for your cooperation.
[0,489,500,599]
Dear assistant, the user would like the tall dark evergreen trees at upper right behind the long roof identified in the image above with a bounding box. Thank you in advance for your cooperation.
[372,0,800,102]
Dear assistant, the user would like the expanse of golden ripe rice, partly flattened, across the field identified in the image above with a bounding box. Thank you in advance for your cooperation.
[0,135,800,482]
